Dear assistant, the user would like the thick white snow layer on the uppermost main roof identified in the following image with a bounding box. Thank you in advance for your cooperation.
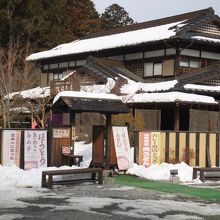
[27,21,183,60]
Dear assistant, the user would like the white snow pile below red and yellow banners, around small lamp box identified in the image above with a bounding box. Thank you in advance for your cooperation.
[126,162,193,182]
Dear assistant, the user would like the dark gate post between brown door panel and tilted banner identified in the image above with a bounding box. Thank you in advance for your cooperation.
[104,114,112,168]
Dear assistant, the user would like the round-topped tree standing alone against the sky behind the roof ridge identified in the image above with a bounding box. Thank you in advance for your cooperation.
[101,4,134,30]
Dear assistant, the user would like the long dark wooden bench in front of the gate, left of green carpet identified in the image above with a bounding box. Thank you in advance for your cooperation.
[41,168,103,189]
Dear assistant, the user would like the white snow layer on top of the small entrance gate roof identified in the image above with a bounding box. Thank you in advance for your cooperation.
[53,91,121,104]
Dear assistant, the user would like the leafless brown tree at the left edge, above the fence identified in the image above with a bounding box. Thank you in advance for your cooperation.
[0,41,39,128]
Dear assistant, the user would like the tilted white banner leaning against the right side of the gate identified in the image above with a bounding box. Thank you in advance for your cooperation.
[112,126,133,170]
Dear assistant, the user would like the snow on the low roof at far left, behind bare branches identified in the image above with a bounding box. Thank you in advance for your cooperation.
[9,87,50,99]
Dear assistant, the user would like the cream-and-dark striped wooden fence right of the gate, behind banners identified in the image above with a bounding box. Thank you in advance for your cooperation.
[135,131,220,167]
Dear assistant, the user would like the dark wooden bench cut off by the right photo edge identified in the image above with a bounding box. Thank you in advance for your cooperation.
[193,167,220,182]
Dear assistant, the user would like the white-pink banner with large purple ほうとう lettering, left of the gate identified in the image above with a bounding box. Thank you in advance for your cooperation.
[24,130,47,169]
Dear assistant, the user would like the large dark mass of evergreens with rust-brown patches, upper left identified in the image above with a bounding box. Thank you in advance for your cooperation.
[0,0,100,50]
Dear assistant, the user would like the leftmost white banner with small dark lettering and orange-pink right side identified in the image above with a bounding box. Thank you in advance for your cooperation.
[2,130,21,167]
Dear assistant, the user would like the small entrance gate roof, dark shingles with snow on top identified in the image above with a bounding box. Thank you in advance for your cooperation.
[52,91,129,114]
